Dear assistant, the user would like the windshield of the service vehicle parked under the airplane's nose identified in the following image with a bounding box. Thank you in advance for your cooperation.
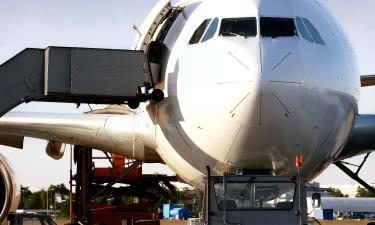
[214,181,295,210]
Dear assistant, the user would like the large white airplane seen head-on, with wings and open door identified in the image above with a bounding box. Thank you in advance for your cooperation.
[0,0,375,224]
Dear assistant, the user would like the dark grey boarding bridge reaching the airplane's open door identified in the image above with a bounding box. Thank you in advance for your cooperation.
[0,47,164,117]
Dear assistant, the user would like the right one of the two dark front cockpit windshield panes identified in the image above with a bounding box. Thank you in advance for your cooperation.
[260,17,297,38]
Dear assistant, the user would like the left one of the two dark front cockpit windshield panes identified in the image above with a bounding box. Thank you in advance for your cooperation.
[219,17,257,38]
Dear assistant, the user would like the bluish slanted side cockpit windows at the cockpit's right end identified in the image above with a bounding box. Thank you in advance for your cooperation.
[296,17,325,45]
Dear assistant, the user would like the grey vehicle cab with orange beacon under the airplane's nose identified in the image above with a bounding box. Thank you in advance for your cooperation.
[204,173,307,225]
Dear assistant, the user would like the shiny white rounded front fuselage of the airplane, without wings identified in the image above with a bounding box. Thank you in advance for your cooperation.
[134,0,360,184]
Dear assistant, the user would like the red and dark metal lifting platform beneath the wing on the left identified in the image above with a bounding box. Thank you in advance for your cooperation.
[70,148,177,225]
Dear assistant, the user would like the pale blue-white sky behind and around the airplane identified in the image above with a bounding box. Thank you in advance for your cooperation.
[0,0,375,190]
